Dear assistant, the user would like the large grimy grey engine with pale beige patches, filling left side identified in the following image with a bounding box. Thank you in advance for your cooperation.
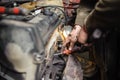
[0,0,67,80]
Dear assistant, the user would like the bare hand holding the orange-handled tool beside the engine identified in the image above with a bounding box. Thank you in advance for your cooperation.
[63,25,87,53]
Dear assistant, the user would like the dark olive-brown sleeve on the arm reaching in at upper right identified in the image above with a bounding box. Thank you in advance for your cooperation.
[85,0,120,33]
